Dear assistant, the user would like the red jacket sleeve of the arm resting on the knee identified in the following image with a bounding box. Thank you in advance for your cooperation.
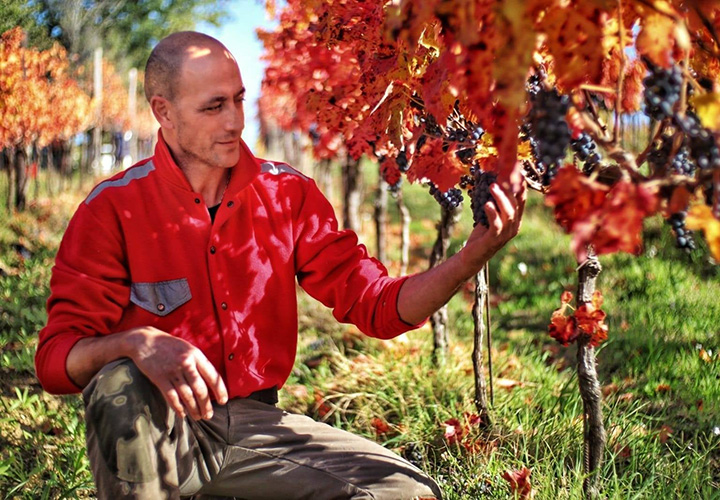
[35,200,130,394]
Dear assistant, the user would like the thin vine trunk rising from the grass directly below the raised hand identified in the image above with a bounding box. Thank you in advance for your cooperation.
[472,265,490,426]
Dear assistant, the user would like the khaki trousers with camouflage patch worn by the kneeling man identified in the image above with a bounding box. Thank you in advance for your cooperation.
[83,359,441,500]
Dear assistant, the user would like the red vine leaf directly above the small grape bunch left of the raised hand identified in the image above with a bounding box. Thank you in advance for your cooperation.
[407,137,467,191]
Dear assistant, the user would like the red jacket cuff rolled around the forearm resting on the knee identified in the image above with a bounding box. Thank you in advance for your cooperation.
[35,332,87,394]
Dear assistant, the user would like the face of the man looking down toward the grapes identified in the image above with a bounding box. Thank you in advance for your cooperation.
[171,47,245,172]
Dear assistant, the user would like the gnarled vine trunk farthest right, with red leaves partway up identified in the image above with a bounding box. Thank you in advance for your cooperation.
[576,254,606,498]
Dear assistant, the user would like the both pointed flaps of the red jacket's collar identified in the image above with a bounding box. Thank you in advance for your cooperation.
[153,129,260,199]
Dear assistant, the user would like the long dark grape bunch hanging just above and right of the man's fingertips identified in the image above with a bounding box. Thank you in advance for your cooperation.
[523,88,570,185]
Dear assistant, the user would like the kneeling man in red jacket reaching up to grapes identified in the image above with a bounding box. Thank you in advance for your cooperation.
[36,32,525,499]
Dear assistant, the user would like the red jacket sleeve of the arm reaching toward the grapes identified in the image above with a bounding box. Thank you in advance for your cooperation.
[295,180,426,339]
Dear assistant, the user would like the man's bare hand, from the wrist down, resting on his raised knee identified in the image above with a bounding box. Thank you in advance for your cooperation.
[126,327,228,420]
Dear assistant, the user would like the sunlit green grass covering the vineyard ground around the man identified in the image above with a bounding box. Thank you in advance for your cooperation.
[0,170,720,499]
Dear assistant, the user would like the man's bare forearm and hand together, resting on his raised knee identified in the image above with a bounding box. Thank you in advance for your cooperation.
[66,326,228,420]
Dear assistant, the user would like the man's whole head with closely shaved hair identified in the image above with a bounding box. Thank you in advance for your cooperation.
[145,31,245,172]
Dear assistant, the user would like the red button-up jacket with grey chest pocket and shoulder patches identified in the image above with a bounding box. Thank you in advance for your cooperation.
[35,135,419,397]
